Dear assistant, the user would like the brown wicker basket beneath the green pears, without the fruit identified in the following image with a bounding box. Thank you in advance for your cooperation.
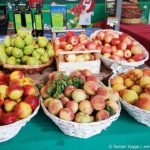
[2,57,54,74]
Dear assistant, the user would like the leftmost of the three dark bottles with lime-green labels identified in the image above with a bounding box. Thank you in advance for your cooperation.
[13,0,22,33]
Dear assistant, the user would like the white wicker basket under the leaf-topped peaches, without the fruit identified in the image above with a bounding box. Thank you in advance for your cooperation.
[41,99,120,138]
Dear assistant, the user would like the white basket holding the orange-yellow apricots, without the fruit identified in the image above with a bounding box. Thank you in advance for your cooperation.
[109,72,150,127]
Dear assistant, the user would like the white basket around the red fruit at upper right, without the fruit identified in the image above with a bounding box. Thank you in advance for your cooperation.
[90,29,149,69]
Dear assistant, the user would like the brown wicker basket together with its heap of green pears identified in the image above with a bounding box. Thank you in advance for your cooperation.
[0,30,54,73]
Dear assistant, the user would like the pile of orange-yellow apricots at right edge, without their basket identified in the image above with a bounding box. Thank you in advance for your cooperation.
[110,68,150,111]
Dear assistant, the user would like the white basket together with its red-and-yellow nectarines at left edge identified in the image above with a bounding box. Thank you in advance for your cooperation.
[0,71,39,142]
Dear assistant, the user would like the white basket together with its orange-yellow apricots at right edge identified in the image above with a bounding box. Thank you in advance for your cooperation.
[110,68,150,127]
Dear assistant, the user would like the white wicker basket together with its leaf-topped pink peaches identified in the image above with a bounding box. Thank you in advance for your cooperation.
[40,70,121,138]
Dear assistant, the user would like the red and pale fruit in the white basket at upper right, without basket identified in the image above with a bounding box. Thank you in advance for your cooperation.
[93,30,145,62]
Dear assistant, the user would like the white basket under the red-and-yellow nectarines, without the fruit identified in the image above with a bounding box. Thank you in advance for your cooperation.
[0,105,40,143]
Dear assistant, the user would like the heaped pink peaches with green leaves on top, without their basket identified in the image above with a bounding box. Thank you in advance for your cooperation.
[40,69,120,123]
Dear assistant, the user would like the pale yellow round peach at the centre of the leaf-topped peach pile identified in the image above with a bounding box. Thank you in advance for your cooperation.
[72,89,87,102]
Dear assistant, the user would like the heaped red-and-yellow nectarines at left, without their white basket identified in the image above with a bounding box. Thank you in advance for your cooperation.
[0,71,39,125]
